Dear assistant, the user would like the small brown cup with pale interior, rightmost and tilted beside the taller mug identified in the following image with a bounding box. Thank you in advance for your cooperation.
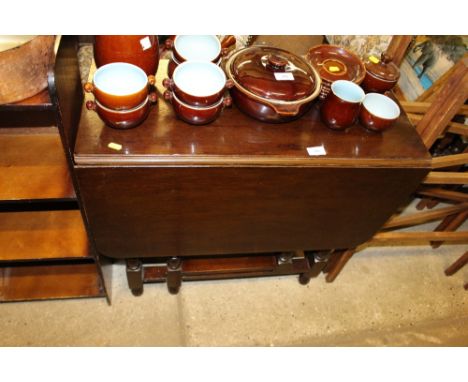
[359,93,400,132]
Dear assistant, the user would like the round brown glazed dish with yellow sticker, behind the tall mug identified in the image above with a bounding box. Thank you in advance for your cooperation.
[306,45,366,99]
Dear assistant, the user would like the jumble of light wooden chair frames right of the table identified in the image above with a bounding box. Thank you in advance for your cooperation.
[323,44,468,289]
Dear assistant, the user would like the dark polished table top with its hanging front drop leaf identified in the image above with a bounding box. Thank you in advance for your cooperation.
[74,59,430,266]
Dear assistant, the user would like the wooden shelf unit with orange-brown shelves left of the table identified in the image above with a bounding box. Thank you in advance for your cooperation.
[0,36,108,302]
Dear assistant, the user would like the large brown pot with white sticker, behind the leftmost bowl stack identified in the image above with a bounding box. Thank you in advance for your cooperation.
[94,35,159,75]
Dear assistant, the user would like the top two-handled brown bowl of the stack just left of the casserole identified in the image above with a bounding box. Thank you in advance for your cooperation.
[163,61,232,107]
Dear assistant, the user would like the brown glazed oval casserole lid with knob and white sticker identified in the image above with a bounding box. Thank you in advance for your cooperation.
[226,46,319,102]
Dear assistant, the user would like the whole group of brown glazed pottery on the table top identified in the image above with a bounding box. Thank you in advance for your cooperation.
[84,35,400,132]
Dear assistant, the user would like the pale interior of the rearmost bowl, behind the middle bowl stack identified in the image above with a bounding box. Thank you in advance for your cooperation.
[174,35,221,61]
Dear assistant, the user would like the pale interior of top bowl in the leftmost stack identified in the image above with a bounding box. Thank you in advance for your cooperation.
[93,62,148,95]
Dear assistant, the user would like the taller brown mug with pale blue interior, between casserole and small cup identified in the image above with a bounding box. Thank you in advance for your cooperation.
[320,80,365,130]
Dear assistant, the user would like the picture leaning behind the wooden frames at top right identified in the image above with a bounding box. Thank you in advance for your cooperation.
[398,35,468,101]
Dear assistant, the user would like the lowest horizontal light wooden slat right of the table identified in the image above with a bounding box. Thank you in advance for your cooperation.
[368,231,468,246]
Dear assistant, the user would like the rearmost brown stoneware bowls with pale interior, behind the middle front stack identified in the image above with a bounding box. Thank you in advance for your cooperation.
[166,35,222,78]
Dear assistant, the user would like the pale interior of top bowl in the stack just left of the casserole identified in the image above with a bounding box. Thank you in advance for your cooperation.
[172,61,226,97]
